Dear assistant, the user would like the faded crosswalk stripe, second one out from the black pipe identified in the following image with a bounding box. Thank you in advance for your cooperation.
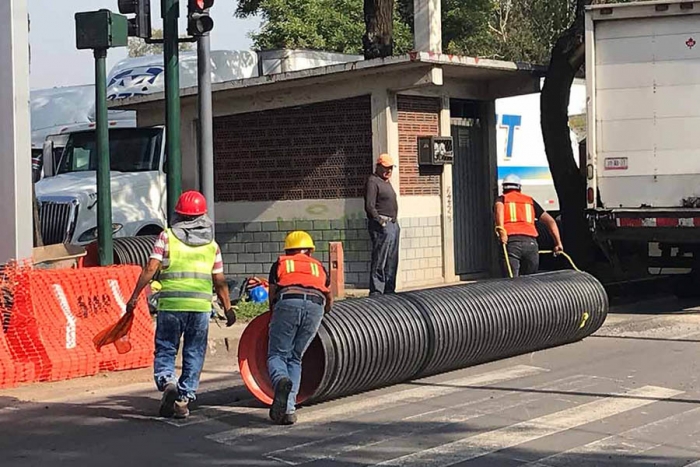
[265,375,600,465]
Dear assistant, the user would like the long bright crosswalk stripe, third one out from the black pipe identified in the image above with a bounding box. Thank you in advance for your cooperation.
[376,386,683,467]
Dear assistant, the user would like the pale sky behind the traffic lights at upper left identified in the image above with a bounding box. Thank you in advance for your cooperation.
[27,0,260,89]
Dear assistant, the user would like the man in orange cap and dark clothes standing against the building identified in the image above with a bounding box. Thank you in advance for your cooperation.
[365,154,401,295]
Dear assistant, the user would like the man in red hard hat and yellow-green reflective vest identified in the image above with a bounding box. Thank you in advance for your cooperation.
[126,191,236,418]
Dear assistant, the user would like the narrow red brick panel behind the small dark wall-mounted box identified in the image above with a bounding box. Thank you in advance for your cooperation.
[397,95,442,196]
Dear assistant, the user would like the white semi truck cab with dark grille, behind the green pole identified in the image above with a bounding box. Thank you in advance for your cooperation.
[35,127,167,245]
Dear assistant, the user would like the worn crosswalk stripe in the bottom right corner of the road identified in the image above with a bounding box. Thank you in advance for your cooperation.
[521,408,700,467]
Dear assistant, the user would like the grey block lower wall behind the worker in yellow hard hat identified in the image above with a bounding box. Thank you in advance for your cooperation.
[216,219,371,289]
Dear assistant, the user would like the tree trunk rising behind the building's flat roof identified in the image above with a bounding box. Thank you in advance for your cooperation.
[362,0,394,60]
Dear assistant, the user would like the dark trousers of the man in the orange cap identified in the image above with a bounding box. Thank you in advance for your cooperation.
[369,219,401,294]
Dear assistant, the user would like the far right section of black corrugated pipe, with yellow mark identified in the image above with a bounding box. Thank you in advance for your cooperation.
[403,271,608,377]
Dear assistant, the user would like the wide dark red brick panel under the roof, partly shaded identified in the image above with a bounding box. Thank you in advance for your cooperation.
[214,96,372,202]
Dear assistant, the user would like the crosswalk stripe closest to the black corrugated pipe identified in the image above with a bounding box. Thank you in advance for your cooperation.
[207,365,549,444]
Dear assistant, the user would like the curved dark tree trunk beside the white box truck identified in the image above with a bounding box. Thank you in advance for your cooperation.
[540,0,595,269]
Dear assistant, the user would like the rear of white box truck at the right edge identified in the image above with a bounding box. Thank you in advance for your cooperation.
[586,0,700,277]
